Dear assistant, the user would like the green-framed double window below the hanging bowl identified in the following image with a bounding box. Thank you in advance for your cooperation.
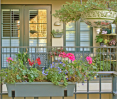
[64,21,93,51]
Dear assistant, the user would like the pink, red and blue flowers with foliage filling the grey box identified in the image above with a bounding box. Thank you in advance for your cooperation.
[0,52,98,86]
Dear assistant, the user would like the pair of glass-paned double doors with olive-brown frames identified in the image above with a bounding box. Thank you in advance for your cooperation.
[1,5,51,67]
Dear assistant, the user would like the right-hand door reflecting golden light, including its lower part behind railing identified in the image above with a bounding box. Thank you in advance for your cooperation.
[24,6,51,67]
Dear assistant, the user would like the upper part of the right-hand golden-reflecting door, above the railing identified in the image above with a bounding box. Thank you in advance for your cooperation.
[24,6,51,48]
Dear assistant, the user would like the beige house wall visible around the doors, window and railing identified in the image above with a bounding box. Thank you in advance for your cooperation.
[1,0,111,99]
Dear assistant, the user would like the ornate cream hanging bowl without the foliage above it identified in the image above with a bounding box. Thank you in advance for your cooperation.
[81,10,117,28]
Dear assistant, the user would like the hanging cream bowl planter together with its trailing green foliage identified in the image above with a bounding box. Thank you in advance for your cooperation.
[53,0,117,27]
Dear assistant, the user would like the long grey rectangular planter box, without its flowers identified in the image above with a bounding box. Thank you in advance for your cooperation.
[6,82,75,97]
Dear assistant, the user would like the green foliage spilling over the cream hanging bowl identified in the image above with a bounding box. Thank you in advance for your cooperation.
[53,0,117,22]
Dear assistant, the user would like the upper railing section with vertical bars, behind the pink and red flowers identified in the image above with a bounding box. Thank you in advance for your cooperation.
[1,46,117,71]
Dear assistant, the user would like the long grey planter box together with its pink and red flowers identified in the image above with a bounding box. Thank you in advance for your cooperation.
[0,52,98,97]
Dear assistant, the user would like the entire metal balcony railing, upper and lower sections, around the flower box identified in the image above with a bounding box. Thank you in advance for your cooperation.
[0,46,117,99]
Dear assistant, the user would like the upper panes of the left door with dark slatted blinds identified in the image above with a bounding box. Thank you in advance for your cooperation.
[2,9,20,37]
